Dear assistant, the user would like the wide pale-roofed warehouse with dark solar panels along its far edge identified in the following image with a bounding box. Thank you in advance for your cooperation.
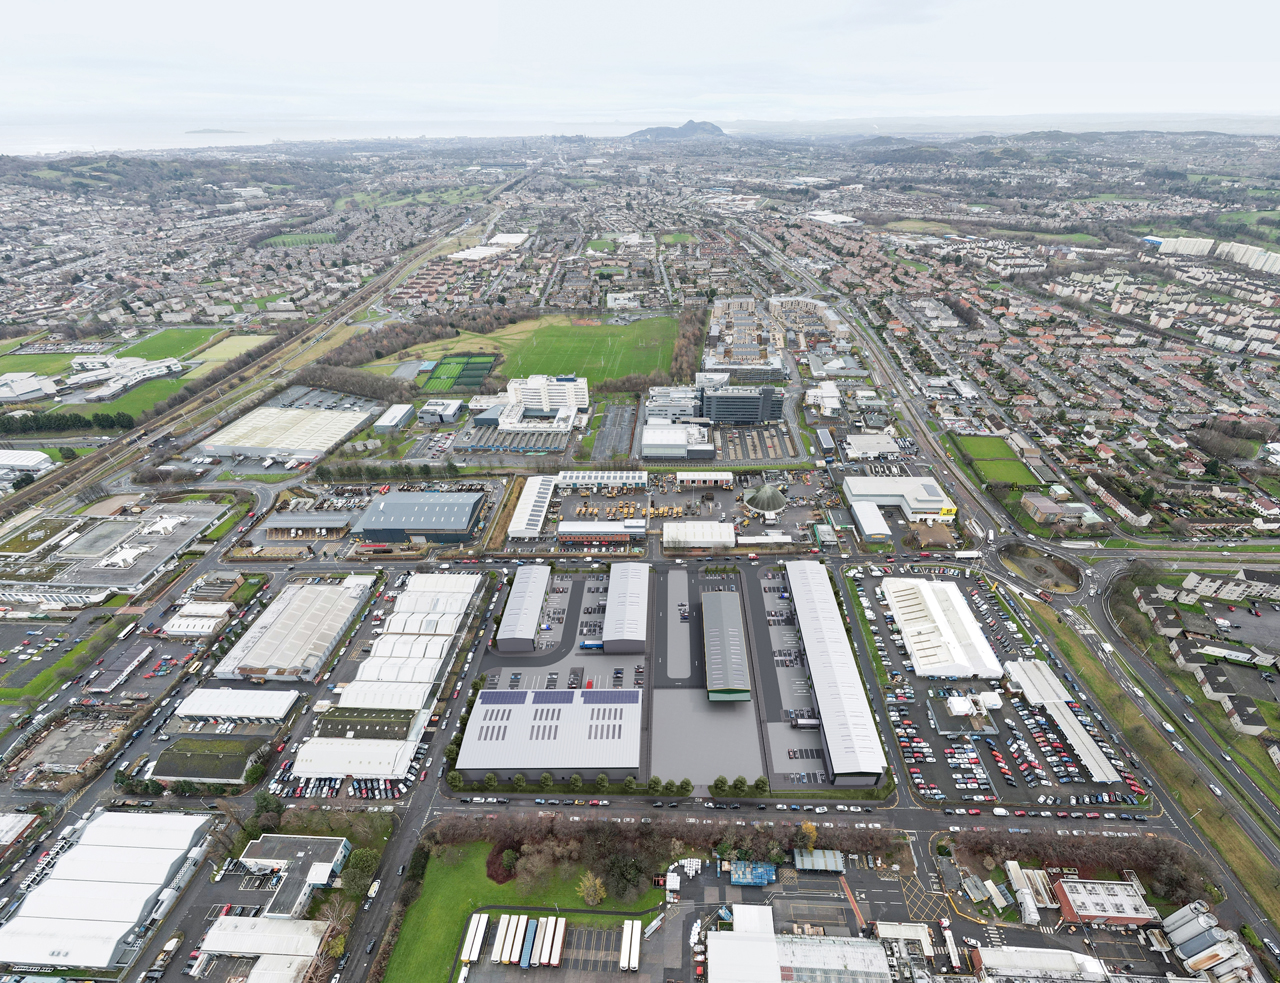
[455,686,648,782]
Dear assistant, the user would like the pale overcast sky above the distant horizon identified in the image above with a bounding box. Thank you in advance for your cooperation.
[0,0,1280,152]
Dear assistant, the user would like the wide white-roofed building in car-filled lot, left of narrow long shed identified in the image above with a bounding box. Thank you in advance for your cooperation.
[881,577,1005,680]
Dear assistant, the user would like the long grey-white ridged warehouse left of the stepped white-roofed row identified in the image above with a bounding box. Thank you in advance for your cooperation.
[215,575,374,682]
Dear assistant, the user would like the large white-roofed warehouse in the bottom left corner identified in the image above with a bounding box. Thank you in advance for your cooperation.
[0,811,208,970]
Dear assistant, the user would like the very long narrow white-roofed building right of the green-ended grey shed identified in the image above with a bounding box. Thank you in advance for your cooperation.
[786,561,888,786]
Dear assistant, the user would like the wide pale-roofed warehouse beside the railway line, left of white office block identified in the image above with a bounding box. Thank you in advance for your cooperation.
[200,406,370,461]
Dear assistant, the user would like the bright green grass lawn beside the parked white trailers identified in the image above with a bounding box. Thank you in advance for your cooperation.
[385,843,662,983]
